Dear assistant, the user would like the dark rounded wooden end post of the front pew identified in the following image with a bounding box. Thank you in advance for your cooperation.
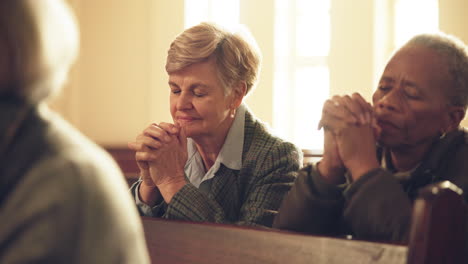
[408,181,468,264]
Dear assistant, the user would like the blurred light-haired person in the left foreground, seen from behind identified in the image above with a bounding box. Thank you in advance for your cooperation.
[0,0,149,263]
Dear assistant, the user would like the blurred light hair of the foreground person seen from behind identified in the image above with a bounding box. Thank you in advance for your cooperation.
[0,0,79,104]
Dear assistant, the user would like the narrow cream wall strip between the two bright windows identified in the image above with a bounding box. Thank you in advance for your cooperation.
[329,0,374,100]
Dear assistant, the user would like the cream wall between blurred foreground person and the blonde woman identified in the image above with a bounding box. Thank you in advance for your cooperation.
[53,0,183,145]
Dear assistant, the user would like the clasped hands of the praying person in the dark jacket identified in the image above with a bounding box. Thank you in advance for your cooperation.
[318,93,380,184]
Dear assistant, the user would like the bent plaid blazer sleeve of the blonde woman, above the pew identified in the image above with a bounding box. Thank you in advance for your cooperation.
[160,140,301,227]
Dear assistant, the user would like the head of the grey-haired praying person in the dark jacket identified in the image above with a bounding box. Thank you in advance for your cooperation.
[373,33,468,150]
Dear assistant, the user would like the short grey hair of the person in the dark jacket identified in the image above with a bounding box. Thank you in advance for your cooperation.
[405,33,468,110]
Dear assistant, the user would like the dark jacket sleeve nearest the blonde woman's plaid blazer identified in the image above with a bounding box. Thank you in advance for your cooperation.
[273,165,344,235]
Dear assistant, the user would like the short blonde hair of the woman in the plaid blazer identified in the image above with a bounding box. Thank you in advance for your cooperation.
[166,23,261,94]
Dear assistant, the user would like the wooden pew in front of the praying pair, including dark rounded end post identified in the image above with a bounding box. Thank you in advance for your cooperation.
[142,182,466,264]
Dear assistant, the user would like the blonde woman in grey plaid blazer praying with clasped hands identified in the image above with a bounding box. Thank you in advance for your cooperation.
[129,23,302,227]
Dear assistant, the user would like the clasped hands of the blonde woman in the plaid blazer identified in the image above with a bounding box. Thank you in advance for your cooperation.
[128,123,187,205]
